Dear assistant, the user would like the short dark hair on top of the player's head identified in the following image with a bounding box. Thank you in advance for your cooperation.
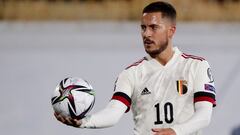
[142,1,177,22]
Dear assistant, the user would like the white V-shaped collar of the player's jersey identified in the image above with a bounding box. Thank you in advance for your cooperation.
[146,47,181,68]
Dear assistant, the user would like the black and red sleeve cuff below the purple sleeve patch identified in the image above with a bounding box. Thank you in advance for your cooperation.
[194,92,216,107]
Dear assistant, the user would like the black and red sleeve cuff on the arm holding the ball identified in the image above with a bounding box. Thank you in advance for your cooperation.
[112,92,131,112]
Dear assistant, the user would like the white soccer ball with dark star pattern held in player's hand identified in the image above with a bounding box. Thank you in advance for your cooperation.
[51,77,95,119]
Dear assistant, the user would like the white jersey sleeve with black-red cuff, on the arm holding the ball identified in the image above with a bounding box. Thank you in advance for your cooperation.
[111,70,134,112]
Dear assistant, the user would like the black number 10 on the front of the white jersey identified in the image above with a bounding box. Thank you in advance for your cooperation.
[154,102,173,125]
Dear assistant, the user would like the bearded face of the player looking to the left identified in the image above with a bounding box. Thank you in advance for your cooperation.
[141,12,176,57]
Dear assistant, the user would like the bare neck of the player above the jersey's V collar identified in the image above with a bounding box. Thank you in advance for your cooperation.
[155,44,174,65]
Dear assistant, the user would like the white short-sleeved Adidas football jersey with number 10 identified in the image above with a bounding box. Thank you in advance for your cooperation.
[112,47,216,135]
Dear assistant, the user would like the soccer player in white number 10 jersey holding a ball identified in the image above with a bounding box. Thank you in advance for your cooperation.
[55,1,216,135]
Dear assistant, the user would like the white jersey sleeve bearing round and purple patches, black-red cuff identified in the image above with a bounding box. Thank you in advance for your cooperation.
[194,61,216,107]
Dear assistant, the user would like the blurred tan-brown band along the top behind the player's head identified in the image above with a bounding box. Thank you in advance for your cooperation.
[0,0,240,21]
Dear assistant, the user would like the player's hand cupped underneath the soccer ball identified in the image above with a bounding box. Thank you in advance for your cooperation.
[54,112,82,127]
